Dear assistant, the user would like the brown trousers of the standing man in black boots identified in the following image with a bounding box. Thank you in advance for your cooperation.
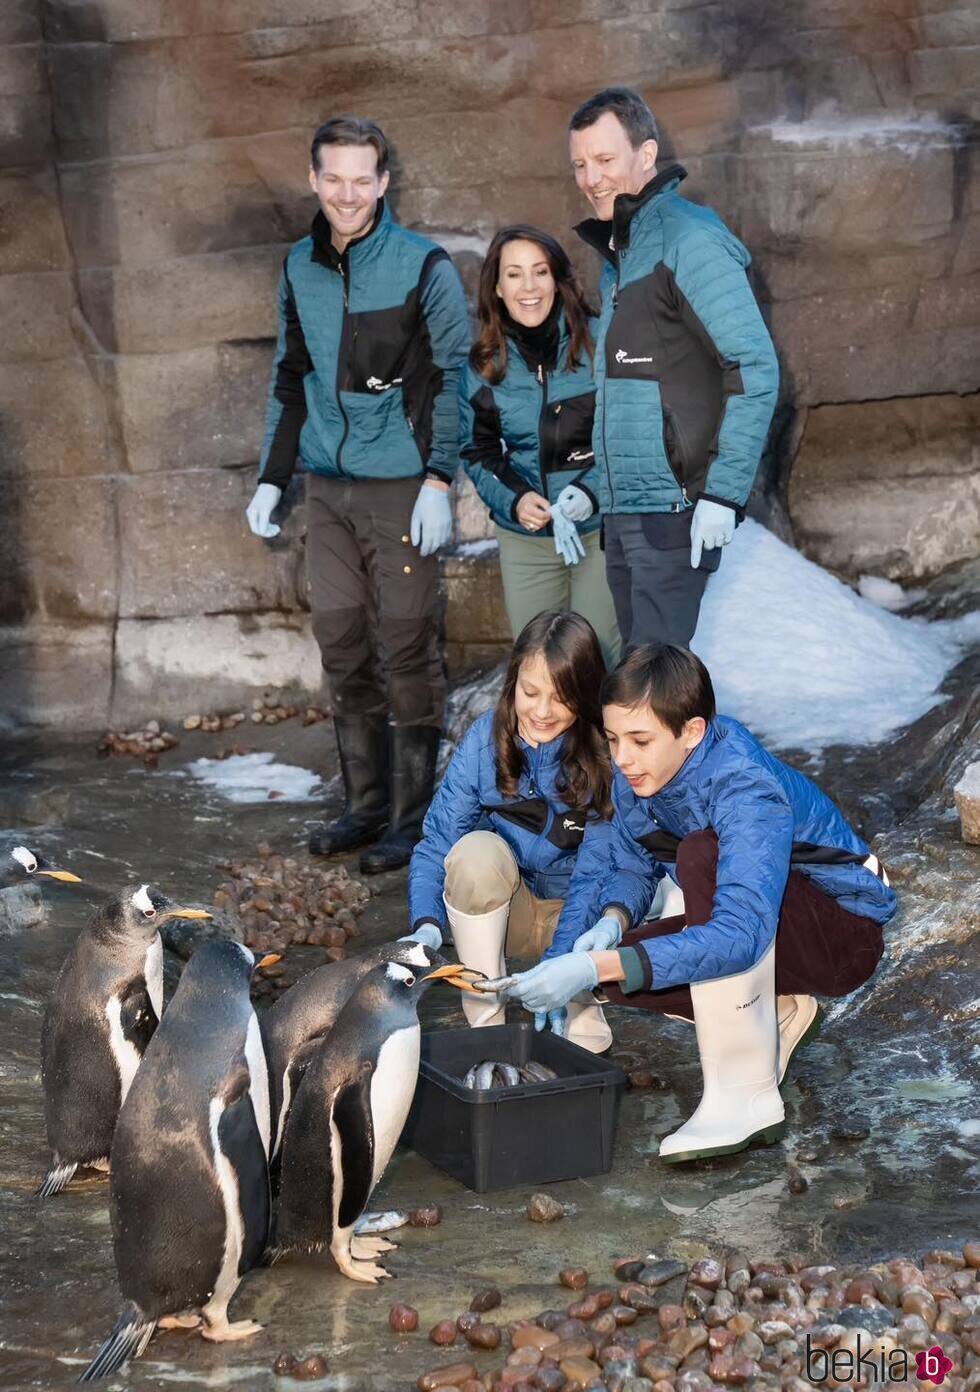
[306,473,445,725]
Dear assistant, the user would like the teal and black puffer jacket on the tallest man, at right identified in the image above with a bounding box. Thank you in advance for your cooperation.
[576,164,778,512]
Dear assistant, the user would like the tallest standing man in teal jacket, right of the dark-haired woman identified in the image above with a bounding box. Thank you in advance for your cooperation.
[558,88,778,649]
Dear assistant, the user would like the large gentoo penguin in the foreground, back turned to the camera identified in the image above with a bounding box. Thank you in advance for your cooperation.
[79,941,278,1382]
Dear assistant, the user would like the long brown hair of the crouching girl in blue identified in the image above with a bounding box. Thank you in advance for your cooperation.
[493,610,613,818]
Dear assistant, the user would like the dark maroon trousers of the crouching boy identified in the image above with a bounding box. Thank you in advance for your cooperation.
[603,831,884,1020]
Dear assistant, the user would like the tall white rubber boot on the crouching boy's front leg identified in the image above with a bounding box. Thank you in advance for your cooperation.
[660,941,785,1164]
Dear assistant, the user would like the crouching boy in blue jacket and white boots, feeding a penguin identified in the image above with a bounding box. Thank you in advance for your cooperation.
[507,646,896,1162]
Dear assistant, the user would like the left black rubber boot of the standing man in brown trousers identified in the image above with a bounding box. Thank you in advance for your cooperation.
[309,715,388,856]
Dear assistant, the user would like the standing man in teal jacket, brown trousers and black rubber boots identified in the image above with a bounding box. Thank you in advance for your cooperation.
[246,116,469,873]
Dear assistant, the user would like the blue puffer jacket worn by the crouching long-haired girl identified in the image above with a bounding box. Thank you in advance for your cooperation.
[408,710,611,930]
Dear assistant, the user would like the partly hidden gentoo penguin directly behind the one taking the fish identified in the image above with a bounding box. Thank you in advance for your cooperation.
[260,941,445,1174]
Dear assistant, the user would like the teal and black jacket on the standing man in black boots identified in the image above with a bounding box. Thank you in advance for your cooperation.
[259,200,469,487]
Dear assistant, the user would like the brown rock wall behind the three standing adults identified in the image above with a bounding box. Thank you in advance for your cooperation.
[0,0,980,728]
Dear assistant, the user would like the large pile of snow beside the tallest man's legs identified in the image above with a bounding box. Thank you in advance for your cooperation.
[692,521,973,750]
